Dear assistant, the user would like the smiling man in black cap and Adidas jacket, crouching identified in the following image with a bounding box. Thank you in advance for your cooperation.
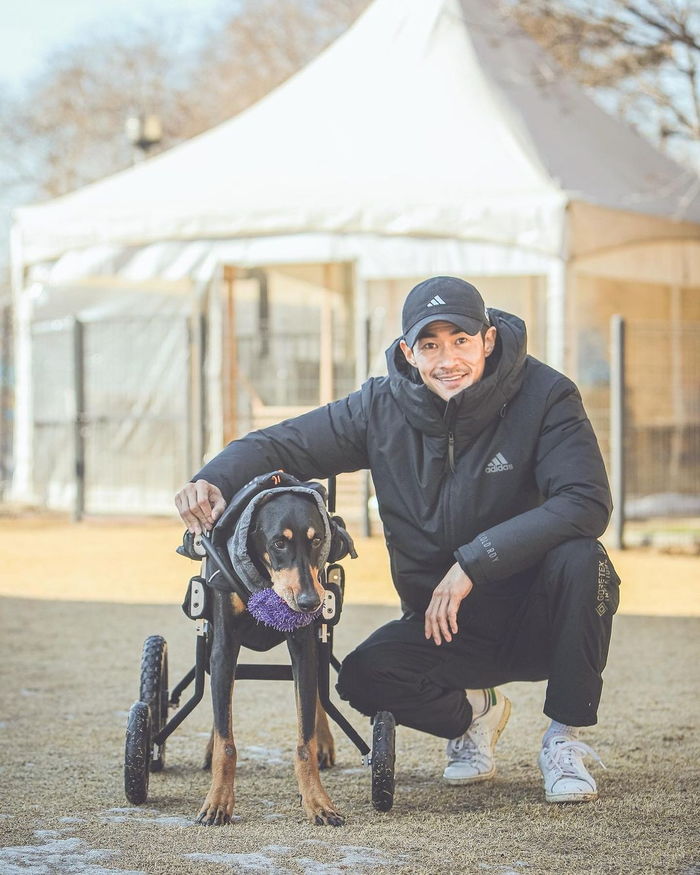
[176,277,619,802]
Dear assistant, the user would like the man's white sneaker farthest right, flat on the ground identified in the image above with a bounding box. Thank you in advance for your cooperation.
[538,735,605,802]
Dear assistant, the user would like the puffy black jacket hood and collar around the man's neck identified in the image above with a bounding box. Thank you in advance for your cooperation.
[386,308,527,441]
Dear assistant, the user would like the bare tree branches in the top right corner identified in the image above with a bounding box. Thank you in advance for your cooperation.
[514,0,700,163]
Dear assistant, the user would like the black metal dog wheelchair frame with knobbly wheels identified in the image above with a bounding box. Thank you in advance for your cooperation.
[124,478,395,812]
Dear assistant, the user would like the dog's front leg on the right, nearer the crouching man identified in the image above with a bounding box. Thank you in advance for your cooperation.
[287,626,344,826]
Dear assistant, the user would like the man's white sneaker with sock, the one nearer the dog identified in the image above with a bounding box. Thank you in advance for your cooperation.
[442,689,510,784]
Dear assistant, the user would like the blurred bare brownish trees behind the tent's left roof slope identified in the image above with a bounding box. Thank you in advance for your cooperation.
[0,0,368,202]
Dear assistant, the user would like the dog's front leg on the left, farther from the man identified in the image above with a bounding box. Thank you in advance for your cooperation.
[197,592,241,826]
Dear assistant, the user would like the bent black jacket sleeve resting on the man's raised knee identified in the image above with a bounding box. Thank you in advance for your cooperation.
[455,379,612,586]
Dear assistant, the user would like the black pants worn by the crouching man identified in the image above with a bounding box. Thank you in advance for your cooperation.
[338,538,620,738]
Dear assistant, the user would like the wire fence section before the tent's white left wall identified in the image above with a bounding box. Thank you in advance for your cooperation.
[32,316,190,518]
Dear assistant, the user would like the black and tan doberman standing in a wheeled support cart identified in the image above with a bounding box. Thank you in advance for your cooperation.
[197,491,344,826]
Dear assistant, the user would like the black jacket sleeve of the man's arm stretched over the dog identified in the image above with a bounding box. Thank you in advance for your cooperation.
[192,387,368,501]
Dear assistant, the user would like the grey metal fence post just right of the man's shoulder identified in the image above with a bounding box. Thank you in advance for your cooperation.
[610,315,625,550]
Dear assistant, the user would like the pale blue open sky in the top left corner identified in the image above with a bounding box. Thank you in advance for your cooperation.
[0,0,226,88]
